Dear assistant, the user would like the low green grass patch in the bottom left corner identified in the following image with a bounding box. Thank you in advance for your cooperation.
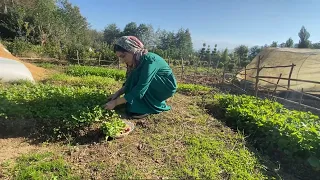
[3,152,80,180]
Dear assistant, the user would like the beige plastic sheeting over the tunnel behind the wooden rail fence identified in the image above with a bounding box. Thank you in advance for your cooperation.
[237,48,320,94]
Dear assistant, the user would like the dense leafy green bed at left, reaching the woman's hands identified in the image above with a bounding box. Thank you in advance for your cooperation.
[0,84,108,137]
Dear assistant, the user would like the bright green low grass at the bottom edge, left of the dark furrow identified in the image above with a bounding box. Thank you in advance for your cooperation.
[180,135,266,180]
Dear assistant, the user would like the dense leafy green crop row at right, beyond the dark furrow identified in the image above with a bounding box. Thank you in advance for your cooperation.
[214,94,320,168]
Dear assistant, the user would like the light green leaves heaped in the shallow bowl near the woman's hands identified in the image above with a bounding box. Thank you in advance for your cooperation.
[100,111,126,139]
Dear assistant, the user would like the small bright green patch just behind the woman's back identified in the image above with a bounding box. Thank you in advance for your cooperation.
[177,84,212,95]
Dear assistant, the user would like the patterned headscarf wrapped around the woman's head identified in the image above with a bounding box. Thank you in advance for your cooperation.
[115,36,148,77]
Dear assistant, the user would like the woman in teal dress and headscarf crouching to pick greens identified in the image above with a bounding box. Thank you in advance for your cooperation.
[105,36,177,119]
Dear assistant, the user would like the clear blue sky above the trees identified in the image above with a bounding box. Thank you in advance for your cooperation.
[70,0,320,49]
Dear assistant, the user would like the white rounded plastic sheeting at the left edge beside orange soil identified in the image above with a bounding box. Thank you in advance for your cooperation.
[0,57,34,82]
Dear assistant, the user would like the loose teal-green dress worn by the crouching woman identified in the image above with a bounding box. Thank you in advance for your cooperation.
[124,52,177,114]
